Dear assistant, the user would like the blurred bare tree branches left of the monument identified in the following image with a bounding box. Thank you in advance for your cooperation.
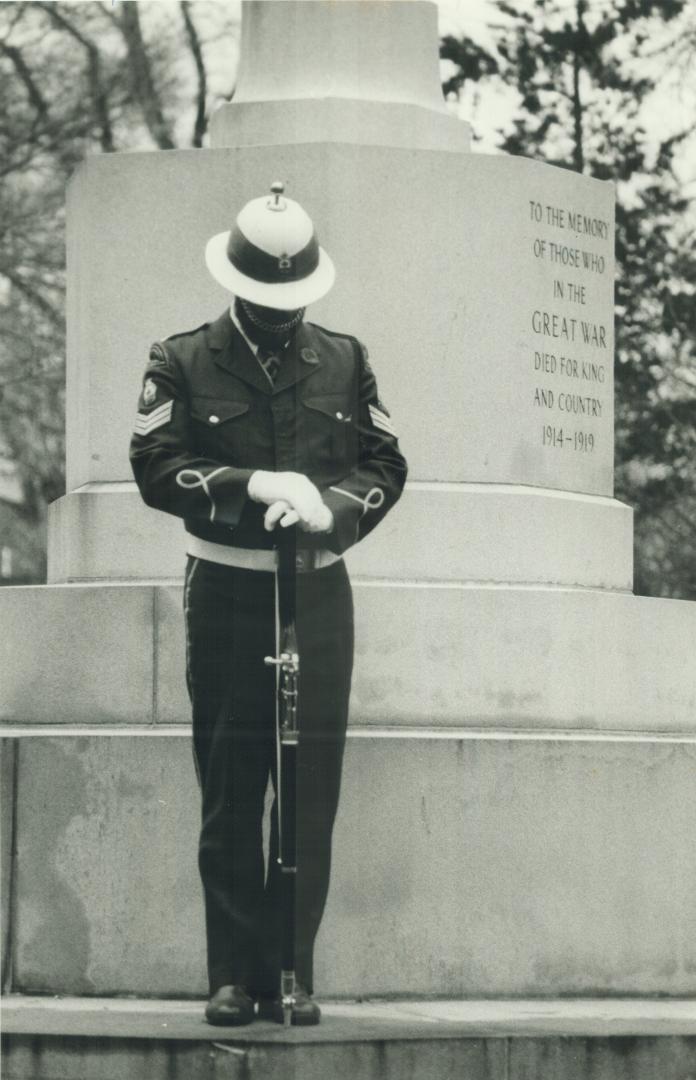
[0,0,239,581]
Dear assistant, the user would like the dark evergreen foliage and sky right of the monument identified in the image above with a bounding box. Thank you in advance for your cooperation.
[442,0,696,598]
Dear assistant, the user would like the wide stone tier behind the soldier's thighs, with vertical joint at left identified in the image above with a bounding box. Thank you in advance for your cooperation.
[0,581,696,733]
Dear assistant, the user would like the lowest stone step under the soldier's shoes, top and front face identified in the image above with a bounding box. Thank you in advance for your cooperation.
[2,996,696,1080]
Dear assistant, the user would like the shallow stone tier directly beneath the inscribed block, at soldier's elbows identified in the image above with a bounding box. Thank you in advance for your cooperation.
[49,482,633,591]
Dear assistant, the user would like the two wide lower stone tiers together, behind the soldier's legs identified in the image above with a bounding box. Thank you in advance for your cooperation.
[5,581,696,996]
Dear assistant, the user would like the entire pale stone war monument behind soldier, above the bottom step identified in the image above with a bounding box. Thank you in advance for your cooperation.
[0,0,696,1010]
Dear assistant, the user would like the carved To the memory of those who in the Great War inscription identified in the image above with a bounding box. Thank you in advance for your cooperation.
[528,199,613,454]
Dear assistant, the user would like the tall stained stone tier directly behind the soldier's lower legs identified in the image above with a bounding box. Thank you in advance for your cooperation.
[4,728,696,998]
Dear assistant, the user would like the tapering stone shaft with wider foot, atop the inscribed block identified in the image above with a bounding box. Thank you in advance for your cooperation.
[211,0,470,151]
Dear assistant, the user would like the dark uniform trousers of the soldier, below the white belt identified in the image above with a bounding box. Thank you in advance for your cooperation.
[184,557,353,996]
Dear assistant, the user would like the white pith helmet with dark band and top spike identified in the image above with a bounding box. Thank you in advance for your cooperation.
[205,181,336,311]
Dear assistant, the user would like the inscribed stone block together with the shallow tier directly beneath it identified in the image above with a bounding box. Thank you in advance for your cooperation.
[50,144,631,589]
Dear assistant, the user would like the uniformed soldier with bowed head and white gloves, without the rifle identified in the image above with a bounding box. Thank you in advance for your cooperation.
[131,184,406,1025]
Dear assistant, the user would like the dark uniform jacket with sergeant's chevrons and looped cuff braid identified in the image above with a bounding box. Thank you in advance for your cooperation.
[131,311,406,553]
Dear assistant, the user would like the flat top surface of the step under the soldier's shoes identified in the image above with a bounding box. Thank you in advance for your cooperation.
[2,995,696,1042]
